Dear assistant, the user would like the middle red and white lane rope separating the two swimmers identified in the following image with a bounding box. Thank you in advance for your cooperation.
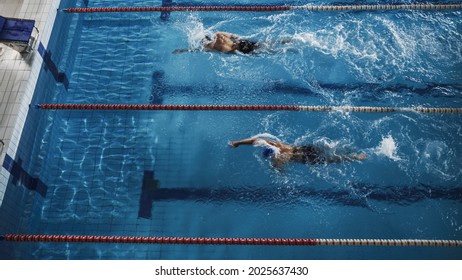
[34,104,462,114]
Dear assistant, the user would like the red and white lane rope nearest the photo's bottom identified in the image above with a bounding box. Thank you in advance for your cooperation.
[0,234,462,247]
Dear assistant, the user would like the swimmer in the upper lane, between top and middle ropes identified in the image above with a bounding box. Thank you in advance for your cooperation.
[173,32,260,54]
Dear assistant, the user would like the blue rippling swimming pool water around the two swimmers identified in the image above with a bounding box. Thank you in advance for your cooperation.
[0,0,462,259]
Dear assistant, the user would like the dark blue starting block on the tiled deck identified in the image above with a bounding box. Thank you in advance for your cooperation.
[0,16,39,52]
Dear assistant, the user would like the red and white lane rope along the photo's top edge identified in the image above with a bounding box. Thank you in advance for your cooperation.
[62,4,462,13]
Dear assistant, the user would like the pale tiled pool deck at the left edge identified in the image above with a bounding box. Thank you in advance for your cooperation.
[0,0,60,205]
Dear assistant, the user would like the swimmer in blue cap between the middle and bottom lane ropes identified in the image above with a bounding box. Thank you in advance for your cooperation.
[229,137,366,171]
